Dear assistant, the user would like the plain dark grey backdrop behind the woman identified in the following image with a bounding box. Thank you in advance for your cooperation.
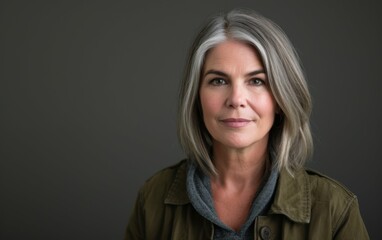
[0,0,382,239]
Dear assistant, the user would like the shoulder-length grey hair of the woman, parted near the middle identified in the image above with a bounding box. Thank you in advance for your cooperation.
[178,10,313,175]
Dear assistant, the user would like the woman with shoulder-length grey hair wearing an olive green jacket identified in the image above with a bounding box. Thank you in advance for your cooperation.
[126,10,368,240]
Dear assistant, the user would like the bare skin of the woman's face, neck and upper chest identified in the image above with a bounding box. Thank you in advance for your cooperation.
[199,40,277,230]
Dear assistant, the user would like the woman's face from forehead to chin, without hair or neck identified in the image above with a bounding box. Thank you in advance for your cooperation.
[199,40,277,149]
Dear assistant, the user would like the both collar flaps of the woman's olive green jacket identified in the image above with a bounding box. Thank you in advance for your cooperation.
[164,160,311,223]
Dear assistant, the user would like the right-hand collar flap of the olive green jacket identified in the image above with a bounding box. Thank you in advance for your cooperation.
[270,169,311,223]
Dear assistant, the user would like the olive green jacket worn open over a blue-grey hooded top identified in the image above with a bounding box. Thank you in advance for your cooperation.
[125,161,369,240]
